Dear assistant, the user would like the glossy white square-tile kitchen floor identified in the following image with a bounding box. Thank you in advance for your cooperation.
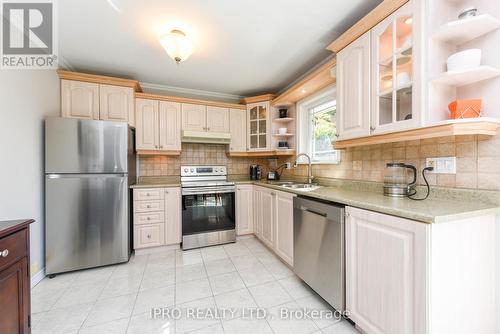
[32,238,358,334]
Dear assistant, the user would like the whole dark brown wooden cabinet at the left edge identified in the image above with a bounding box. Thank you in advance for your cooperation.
[0,220,33,334]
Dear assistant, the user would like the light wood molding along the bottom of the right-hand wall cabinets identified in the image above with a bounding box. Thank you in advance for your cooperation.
[333,117,500,149]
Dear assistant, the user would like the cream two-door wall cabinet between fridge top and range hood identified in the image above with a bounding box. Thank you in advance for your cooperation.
[135,99,181,153]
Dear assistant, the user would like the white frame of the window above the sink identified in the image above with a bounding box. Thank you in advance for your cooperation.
[296,85,341,165]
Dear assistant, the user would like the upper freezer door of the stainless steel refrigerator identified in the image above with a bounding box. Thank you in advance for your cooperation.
[45,117,129,174]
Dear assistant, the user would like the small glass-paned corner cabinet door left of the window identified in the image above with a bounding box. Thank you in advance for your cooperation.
[247,101,270,151]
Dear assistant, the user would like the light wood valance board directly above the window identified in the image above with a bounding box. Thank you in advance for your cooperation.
[271,58,337,106]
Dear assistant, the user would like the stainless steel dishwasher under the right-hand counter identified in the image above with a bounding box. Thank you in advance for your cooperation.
[293,196,345,311]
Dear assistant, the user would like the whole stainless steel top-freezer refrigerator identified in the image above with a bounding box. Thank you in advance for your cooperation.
[45,117,136,275]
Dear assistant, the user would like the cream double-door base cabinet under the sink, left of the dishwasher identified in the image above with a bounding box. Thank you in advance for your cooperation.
[254,186,295,266]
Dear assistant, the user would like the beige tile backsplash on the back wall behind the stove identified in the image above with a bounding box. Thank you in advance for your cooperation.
[139,144,274,176]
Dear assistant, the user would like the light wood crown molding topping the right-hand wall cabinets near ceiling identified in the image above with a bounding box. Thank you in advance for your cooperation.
[327,0,409,53]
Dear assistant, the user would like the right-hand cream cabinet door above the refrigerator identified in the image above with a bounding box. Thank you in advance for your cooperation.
[99,85,135,126]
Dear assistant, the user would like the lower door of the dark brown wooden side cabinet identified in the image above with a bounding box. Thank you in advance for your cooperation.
[0,258,30,334]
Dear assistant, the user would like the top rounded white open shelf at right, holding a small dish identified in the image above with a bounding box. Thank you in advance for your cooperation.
[432,14,500,45]
